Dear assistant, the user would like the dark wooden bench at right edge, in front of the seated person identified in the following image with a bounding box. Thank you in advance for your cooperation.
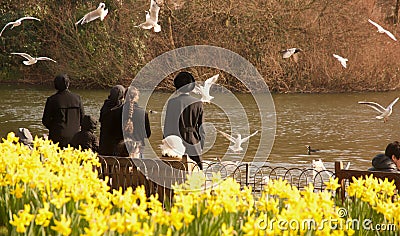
[335,161,400,202]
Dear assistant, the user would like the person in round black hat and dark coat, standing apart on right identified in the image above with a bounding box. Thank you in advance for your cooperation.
[164,71,205,169]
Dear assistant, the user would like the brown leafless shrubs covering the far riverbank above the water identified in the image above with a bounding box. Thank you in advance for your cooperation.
[0,0,400,92]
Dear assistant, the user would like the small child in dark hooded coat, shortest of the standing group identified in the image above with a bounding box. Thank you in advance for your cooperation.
[71,115,99,152]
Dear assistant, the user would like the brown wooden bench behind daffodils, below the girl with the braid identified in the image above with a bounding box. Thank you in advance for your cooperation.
[97,155,196,203]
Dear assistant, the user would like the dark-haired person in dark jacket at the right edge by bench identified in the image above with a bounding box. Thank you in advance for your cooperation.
[368,141,400,172]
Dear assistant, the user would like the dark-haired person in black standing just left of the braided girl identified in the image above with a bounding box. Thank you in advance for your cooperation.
[99,85,125,156]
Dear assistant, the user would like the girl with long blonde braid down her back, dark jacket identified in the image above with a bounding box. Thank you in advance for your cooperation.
[123,86,151,158]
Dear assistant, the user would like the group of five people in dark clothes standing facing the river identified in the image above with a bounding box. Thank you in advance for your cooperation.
[42,71,205,168]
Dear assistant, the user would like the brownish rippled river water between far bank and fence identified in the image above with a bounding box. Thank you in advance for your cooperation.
[0,85,400,170]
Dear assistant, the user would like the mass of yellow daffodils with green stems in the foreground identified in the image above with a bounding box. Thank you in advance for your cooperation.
[0,133,400,235]
